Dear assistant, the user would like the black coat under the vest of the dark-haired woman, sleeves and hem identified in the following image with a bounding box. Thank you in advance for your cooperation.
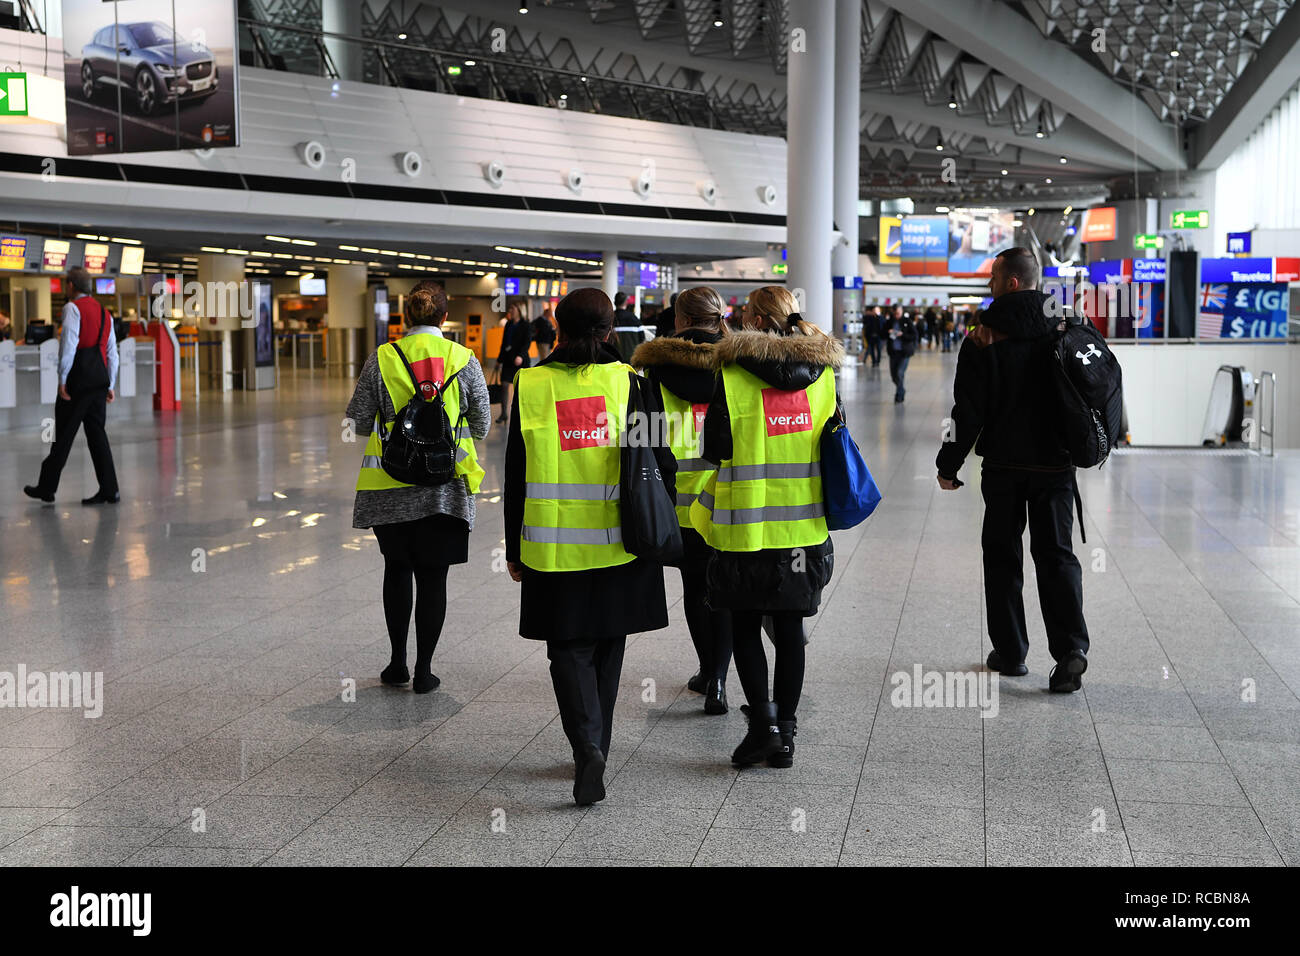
[504,345,677,641]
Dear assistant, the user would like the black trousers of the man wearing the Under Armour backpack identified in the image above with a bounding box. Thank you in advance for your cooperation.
[980,468,1088,662]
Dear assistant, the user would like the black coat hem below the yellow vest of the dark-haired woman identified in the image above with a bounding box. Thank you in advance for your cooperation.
[519,558,668,641]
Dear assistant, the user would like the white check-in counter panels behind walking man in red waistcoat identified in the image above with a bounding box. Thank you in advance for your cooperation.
[0,337,155,432]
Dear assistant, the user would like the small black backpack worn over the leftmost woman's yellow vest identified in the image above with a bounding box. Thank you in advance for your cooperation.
[380,343,465,488]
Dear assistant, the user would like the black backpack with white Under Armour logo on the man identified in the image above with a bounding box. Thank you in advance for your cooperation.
[1052,315,1125,468]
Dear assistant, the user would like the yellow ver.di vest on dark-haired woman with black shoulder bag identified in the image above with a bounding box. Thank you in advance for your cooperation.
[515,362,633,571]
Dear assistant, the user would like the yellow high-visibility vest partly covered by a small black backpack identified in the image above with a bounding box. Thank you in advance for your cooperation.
[356,333,484,494]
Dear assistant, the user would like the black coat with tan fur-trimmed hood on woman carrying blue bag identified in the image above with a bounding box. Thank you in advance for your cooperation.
[703,323,844,618]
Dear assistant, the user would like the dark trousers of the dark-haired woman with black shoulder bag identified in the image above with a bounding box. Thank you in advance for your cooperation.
[546,636,628,757]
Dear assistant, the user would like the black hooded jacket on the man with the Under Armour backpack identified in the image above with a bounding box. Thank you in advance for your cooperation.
[935,290,1070,479]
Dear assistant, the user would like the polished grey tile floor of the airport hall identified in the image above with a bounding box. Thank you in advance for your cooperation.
[0,352,1300,866]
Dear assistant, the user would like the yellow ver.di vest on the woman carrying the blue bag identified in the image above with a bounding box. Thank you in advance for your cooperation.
[690,364,835,551]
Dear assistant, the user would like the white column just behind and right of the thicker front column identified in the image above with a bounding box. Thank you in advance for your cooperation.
[831,3,862,351]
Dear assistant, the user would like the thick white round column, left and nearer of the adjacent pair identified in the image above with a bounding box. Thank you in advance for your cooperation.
[785,0,832,332]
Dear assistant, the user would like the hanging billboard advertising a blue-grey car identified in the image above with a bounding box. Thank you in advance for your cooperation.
[62,0,239,156]
